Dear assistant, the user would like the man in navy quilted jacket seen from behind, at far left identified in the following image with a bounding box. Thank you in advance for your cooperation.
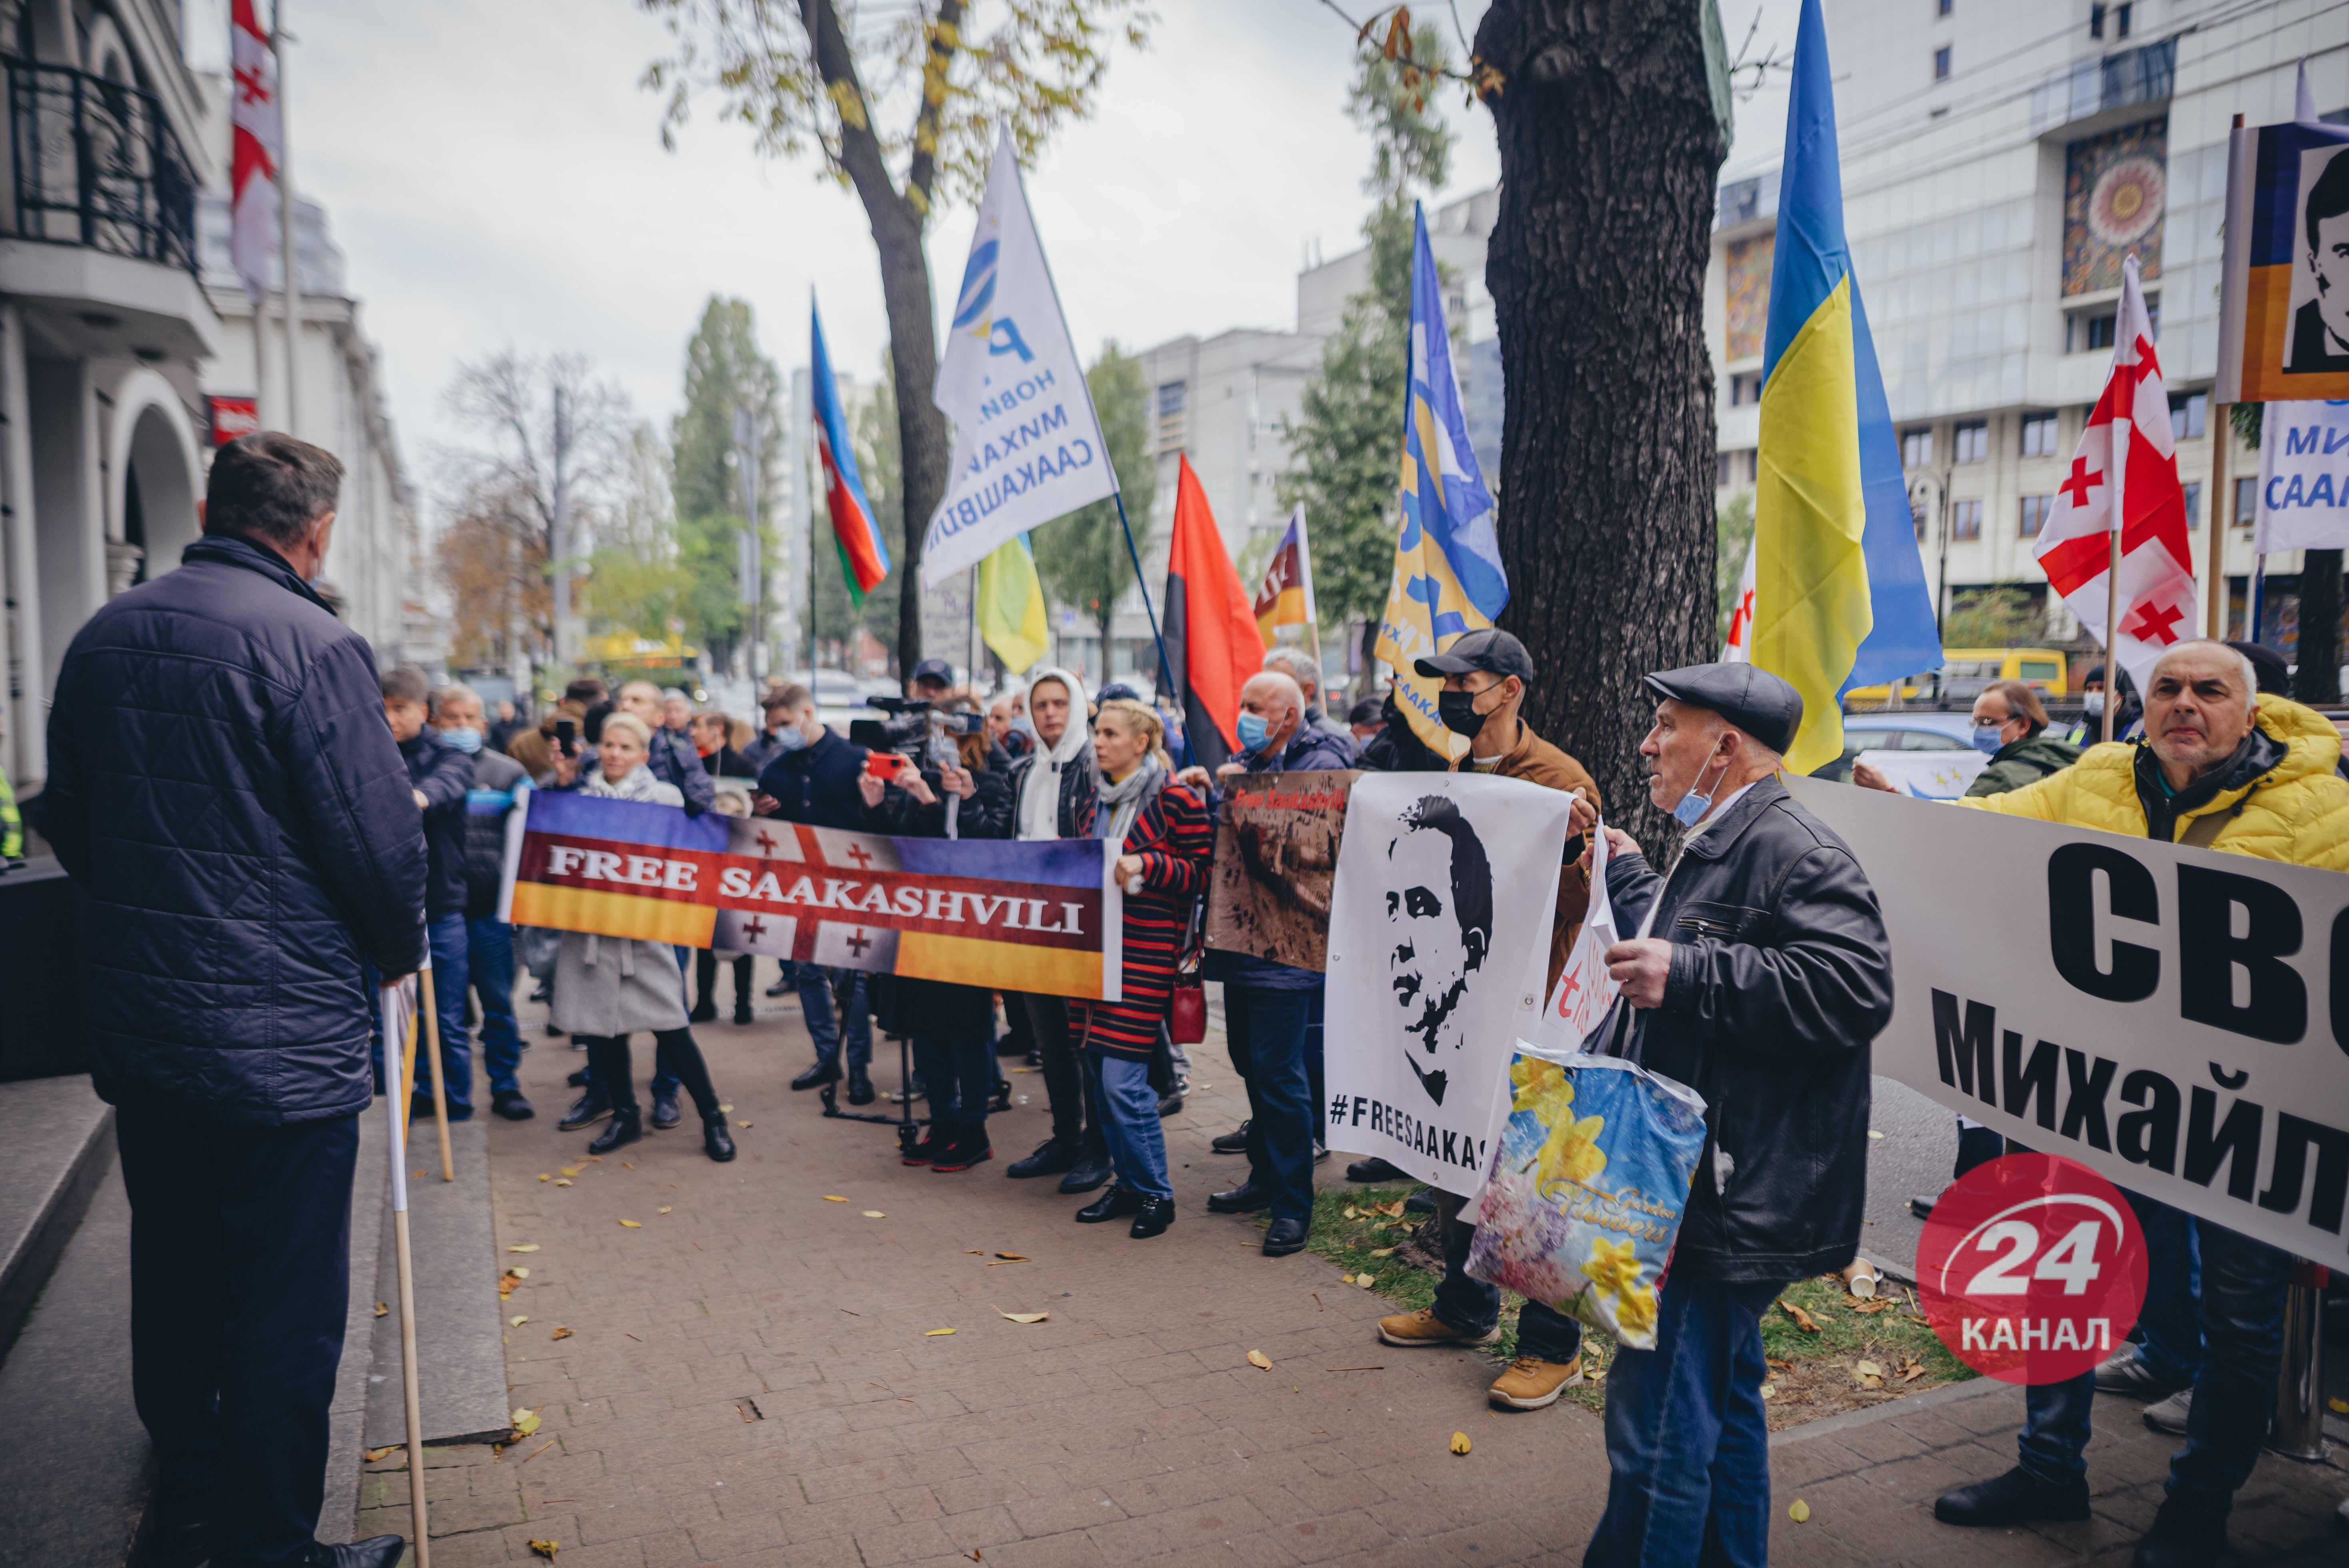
[38,432,425,1568]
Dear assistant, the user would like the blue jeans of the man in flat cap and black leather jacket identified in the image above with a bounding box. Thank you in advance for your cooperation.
[1583,1274,1785,1568]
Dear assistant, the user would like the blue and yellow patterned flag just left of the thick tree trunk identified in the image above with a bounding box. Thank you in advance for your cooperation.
[1374,204,1508,756]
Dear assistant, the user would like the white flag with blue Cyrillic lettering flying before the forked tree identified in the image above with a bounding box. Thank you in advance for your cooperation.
[921,134,1118,587]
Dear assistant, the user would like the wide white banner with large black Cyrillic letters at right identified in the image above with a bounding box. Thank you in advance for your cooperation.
[1787,779,2349,1263]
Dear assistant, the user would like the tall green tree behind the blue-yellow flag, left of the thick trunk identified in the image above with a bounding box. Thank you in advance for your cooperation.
[1278,28,1452,662]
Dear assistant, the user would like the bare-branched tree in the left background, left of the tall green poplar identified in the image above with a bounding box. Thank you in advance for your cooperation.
[442,348,634,664]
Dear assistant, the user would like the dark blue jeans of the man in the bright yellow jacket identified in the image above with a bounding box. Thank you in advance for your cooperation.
[2015,1220,2293,1519]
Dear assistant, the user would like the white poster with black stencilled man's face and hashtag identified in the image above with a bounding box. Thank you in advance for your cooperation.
[1322,772,1569,1197]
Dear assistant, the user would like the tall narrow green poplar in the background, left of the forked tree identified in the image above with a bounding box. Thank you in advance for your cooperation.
[670,294,785,669]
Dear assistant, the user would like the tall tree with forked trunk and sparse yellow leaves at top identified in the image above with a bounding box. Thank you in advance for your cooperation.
[644,0,1151,669]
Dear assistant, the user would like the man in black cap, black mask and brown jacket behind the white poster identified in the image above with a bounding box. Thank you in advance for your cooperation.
[1346,629,1600,1411]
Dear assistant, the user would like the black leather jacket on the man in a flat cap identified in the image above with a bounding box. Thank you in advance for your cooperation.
[1607,777,1893,1282]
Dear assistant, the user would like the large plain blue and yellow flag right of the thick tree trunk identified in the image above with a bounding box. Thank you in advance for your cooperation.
[1752,0,1940,772]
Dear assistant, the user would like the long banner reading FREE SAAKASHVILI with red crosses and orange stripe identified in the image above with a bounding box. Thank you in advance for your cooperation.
[500,789,1125,1002]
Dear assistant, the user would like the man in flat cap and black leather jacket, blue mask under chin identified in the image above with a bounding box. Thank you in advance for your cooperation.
[1574,664,1893,1568]
